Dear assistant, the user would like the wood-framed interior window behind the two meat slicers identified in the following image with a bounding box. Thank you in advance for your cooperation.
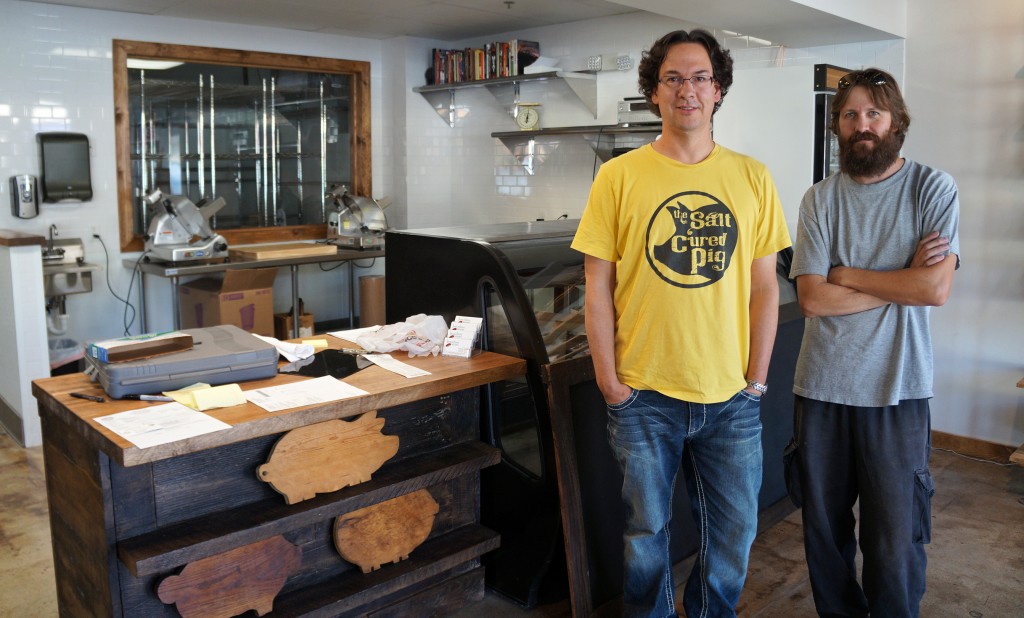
[114,40,372,252]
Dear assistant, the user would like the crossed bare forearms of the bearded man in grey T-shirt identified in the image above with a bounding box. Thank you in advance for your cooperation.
[797,232,956,317]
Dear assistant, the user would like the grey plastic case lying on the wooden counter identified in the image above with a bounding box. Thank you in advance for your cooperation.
[85,324,278,399]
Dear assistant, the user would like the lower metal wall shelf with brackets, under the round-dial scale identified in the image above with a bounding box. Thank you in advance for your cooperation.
[490,124,662,175]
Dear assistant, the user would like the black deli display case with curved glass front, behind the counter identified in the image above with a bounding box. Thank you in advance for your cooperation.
[385,220,589,607]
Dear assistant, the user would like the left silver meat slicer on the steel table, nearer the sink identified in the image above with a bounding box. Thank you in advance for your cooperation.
[143,189,227,262]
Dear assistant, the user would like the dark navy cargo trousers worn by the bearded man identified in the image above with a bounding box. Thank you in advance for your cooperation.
[788,396,934,618]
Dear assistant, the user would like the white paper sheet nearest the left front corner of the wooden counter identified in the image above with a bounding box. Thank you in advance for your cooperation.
[95,402,231,448]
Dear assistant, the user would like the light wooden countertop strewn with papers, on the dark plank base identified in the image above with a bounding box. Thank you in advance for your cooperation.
[32,352,526,467]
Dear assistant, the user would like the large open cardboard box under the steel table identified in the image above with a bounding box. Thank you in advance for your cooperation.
[178,268,278,337]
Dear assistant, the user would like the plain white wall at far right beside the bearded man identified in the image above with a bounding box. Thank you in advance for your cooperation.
[904,0,1024,447]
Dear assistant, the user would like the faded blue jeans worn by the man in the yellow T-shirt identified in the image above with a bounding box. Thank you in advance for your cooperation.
[608,390,762,618]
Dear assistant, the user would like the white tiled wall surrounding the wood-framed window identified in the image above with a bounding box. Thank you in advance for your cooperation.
[0,0,389,347]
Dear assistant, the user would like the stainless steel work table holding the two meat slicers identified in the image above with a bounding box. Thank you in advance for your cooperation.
[122,249,384,338]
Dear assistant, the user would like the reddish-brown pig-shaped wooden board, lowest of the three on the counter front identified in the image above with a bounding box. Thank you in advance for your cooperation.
[157,536,302,618]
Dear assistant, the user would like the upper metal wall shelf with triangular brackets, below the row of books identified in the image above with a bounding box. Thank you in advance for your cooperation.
[413,71,597,127]
